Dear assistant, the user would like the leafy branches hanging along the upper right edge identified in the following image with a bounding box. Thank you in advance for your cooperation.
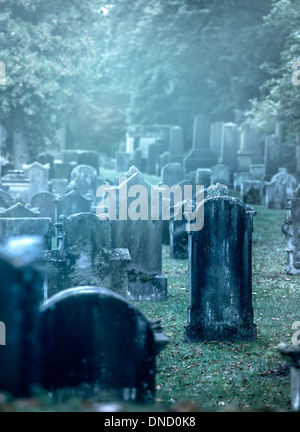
[249,0,300,137]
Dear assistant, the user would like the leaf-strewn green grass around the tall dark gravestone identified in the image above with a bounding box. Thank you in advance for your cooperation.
[137,207,300,411]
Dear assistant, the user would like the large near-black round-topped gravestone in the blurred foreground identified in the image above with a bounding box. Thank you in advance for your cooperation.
[40,287,163,402]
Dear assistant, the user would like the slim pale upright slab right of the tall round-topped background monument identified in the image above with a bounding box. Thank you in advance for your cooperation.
[221,123,239,172]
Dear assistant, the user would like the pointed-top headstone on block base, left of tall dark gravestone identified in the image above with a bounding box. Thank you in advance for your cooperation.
[112,167,168,300]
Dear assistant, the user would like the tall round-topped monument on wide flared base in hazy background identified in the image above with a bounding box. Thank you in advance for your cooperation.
[184,115,218,173]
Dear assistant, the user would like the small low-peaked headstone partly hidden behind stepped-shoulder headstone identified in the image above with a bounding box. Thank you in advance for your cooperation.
[55,190,92,221]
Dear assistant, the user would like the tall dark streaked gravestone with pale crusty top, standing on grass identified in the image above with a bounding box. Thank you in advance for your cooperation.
[185,185,256,342]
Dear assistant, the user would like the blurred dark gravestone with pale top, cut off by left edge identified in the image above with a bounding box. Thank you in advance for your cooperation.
[0,238,43,397]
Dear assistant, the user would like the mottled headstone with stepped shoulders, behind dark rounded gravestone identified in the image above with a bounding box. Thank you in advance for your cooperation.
[45,213,130,298]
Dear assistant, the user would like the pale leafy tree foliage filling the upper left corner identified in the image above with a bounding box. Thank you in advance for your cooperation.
[0,0,102,154]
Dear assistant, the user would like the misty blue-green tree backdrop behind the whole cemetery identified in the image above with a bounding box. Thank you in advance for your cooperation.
[0,0,300,160]
